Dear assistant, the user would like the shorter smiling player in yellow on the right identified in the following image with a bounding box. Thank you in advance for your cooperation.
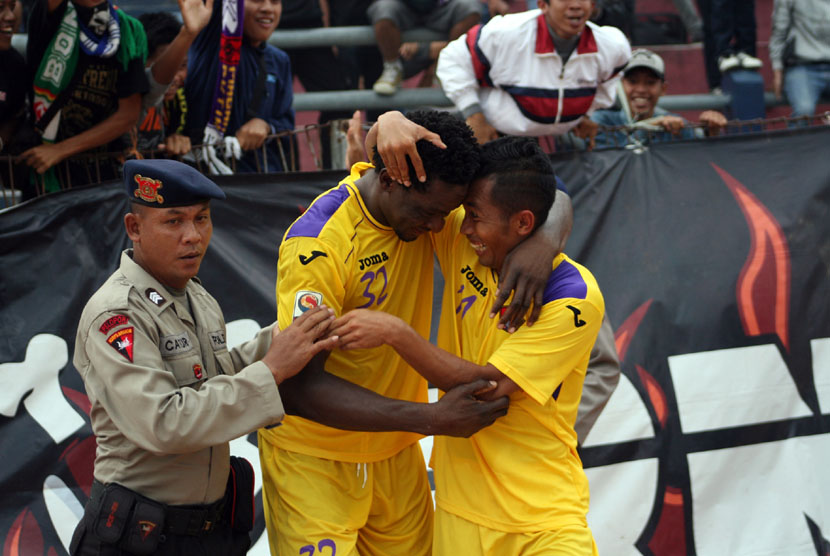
[332,137,605,556]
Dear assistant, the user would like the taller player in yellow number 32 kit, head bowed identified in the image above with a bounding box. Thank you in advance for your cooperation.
[259,112,520,556]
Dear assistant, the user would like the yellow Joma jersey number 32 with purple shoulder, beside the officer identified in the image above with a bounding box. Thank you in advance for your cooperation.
[261,163,433,463]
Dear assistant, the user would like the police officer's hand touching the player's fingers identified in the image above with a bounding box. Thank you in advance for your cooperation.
[262,305,339,384]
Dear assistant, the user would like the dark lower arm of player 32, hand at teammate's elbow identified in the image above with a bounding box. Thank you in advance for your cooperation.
[279,354,509,437]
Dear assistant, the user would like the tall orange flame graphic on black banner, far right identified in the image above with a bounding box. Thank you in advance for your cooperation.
[712,164,791,351]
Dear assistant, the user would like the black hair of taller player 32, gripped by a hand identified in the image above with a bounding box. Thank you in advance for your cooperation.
[372,110,480,192]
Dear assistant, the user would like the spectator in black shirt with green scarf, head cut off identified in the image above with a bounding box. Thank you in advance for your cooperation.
[21,0,148,191]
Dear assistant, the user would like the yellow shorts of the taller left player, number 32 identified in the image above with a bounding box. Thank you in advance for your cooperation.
[259,435,433,556]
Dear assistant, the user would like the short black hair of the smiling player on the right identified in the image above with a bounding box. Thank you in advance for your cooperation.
[476,137,556,228]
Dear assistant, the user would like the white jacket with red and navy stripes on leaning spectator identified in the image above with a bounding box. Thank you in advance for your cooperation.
[437,10,631,135]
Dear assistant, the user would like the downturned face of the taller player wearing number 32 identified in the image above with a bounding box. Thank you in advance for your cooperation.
[383,179,467,241]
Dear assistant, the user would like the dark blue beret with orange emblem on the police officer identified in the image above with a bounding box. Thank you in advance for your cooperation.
[124,159,225,208]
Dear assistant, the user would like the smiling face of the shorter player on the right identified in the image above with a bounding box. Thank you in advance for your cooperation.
[461,177,522,270]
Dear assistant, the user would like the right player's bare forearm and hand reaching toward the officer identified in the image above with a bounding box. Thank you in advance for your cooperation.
[329,309,519,399]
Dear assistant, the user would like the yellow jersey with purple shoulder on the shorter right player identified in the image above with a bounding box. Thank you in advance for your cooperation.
[431,207,605,532]
